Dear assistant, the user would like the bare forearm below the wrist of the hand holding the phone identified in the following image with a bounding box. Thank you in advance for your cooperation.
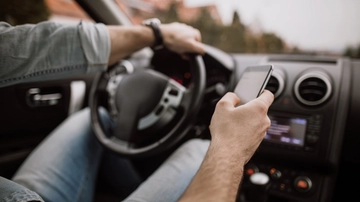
[179,143,245,202]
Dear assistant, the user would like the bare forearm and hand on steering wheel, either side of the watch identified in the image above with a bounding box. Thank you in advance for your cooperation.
[107,22,205,65]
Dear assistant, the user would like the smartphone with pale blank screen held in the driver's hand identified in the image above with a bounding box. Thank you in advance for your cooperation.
[234,65,273,105]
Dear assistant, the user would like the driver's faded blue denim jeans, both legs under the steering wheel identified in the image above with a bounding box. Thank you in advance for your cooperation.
[0,108,209,202]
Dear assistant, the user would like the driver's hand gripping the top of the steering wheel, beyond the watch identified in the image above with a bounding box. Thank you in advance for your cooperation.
[160,22,205,56]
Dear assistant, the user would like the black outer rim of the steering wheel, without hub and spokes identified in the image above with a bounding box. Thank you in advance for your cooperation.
[89,54,206,157]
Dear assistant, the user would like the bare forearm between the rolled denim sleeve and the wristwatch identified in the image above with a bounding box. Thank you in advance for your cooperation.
[107,25,155,65]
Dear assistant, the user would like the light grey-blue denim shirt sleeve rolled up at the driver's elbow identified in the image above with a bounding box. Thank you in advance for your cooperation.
[0,21,110,87]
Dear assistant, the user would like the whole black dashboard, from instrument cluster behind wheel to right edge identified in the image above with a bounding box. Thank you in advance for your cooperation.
[150,47,360,202]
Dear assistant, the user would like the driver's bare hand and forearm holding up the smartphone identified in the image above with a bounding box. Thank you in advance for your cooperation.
[180,90,274,202]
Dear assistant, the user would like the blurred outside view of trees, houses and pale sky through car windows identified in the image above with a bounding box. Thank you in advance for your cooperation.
[0,0,360,58]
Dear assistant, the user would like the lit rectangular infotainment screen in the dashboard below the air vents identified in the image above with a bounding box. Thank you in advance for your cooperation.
[265,115,306,146]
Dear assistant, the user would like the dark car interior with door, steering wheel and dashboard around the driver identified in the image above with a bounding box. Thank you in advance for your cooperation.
[0,0,360,202]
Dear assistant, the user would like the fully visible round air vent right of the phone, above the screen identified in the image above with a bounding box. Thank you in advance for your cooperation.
[294,72,332,106]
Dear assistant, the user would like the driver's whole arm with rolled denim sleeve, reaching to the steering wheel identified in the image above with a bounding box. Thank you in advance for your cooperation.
[0,19,205,87]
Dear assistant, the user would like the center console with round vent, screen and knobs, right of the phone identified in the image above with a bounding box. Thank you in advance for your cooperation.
[233,57,350,202]
